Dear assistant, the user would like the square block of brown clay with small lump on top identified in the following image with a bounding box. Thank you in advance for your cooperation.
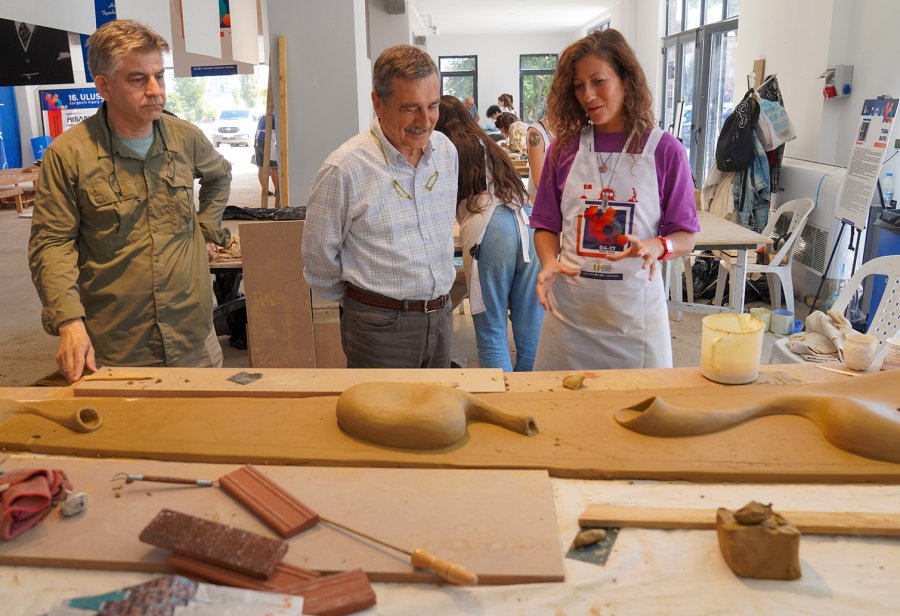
[716,501,800,580]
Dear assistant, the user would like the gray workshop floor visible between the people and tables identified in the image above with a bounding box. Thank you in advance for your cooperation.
[0,147,792,387]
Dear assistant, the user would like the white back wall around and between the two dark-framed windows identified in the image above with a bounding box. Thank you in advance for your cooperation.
[428,33,577,120]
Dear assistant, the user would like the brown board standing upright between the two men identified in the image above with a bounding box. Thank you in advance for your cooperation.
[239,220,316,368]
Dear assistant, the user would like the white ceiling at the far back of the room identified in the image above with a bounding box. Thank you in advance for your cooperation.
[407,0,613,35]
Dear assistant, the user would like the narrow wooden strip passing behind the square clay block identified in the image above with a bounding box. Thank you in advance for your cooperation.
[578,505,900,537]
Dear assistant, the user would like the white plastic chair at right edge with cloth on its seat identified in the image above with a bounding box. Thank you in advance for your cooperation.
[769,255,900,364]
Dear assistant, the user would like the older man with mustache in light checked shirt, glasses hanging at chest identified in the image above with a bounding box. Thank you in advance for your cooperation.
[303,45,459,368]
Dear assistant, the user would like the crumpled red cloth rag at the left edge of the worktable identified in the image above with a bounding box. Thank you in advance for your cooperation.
[0,468,72,539]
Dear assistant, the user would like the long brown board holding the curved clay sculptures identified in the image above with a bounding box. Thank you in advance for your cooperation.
[0,373,900,483]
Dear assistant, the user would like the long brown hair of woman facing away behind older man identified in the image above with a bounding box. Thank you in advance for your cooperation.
[434,94,528,213]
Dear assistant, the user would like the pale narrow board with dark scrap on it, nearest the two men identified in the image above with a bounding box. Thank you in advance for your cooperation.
[72,368,506,398]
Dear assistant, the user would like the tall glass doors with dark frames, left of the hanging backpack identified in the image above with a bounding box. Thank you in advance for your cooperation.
[662,0,743,186]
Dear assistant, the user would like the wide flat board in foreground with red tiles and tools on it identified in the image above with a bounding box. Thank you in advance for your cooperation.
[0,458,564,584]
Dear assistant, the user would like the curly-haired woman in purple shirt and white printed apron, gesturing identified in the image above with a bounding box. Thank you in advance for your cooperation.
[531,30,699,370]
